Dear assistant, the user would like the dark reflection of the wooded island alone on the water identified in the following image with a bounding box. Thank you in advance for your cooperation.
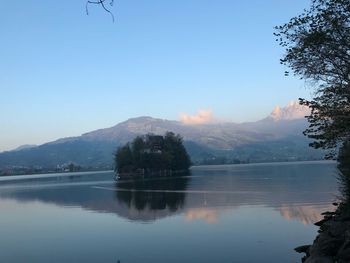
[116,171,190,212]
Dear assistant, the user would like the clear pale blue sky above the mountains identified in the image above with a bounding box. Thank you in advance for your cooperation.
[0,0,312,151]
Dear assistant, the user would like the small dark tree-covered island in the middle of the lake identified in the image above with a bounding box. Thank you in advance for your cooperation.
[114,132,191,178]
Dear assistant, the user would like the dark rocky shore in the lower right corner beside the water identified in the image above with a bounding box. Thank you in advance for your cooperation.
[295,203,350,263]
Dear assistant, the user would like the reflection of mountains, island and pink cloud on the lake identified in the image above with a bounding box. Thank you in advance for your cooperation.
[0,165,336,224]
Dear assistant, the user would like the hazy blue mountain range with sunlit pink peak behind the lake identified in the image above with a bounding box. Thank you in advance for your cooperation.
[0,102,323,173]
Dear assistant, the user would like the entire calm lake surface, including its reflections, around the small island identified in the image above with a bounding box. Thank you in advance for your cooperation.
[0,162,337,263]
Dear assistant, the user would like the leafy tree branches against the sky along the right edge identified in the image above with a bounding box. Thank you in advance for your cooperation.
[275,0,350,156]
